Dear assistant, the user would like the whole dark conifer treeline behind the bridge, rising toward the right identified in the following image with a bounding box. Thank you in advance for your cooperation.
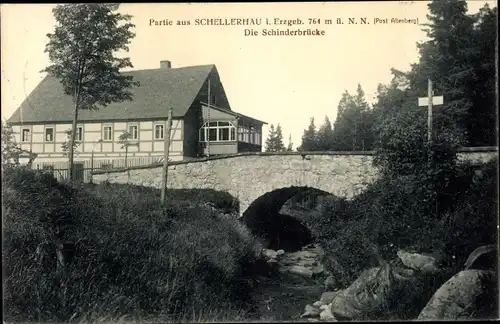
[266,1,498,151]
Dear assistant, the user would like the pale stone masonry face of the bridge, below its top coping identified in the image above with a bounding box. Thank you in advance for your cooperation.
[93,154,378,213]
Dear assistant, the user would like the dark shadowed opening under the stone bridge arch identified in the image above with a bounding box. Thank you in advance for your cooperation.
[242,186,332,252]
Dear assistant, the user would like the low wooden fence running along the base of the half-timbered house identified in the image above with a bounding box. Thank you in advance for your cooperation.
[32,156,163,182]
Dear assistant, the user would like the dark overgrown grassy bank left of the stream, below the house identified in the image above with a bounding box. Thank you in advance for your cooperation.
[2,169,262,321]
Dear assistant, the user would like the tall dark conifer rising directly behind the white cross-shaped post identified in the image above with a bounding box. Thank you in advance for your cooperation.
[410,0,484,145]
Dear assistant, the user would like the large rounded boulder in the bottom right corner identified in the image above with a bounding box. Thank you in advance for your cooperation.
[417,270,497,320]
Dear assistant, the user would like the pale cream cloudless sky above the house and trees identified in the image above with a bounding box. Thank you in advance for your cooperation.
[0,0,496,148]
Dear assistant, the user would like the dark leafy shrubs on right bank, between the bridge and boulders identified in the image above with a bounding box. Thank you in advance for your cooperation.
[307,155,498,286]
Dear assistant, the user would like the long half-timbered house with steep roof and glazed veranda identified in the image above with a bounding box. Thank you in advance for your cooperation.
[8,61,266,162]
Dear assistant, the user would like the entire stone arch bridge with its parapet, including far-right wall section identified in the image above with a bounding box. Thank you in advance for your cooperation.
[93,147,498,216]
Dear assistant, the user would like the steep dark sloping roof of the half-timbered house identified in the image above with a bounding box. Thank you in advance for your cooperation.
[9,65,217,123]
